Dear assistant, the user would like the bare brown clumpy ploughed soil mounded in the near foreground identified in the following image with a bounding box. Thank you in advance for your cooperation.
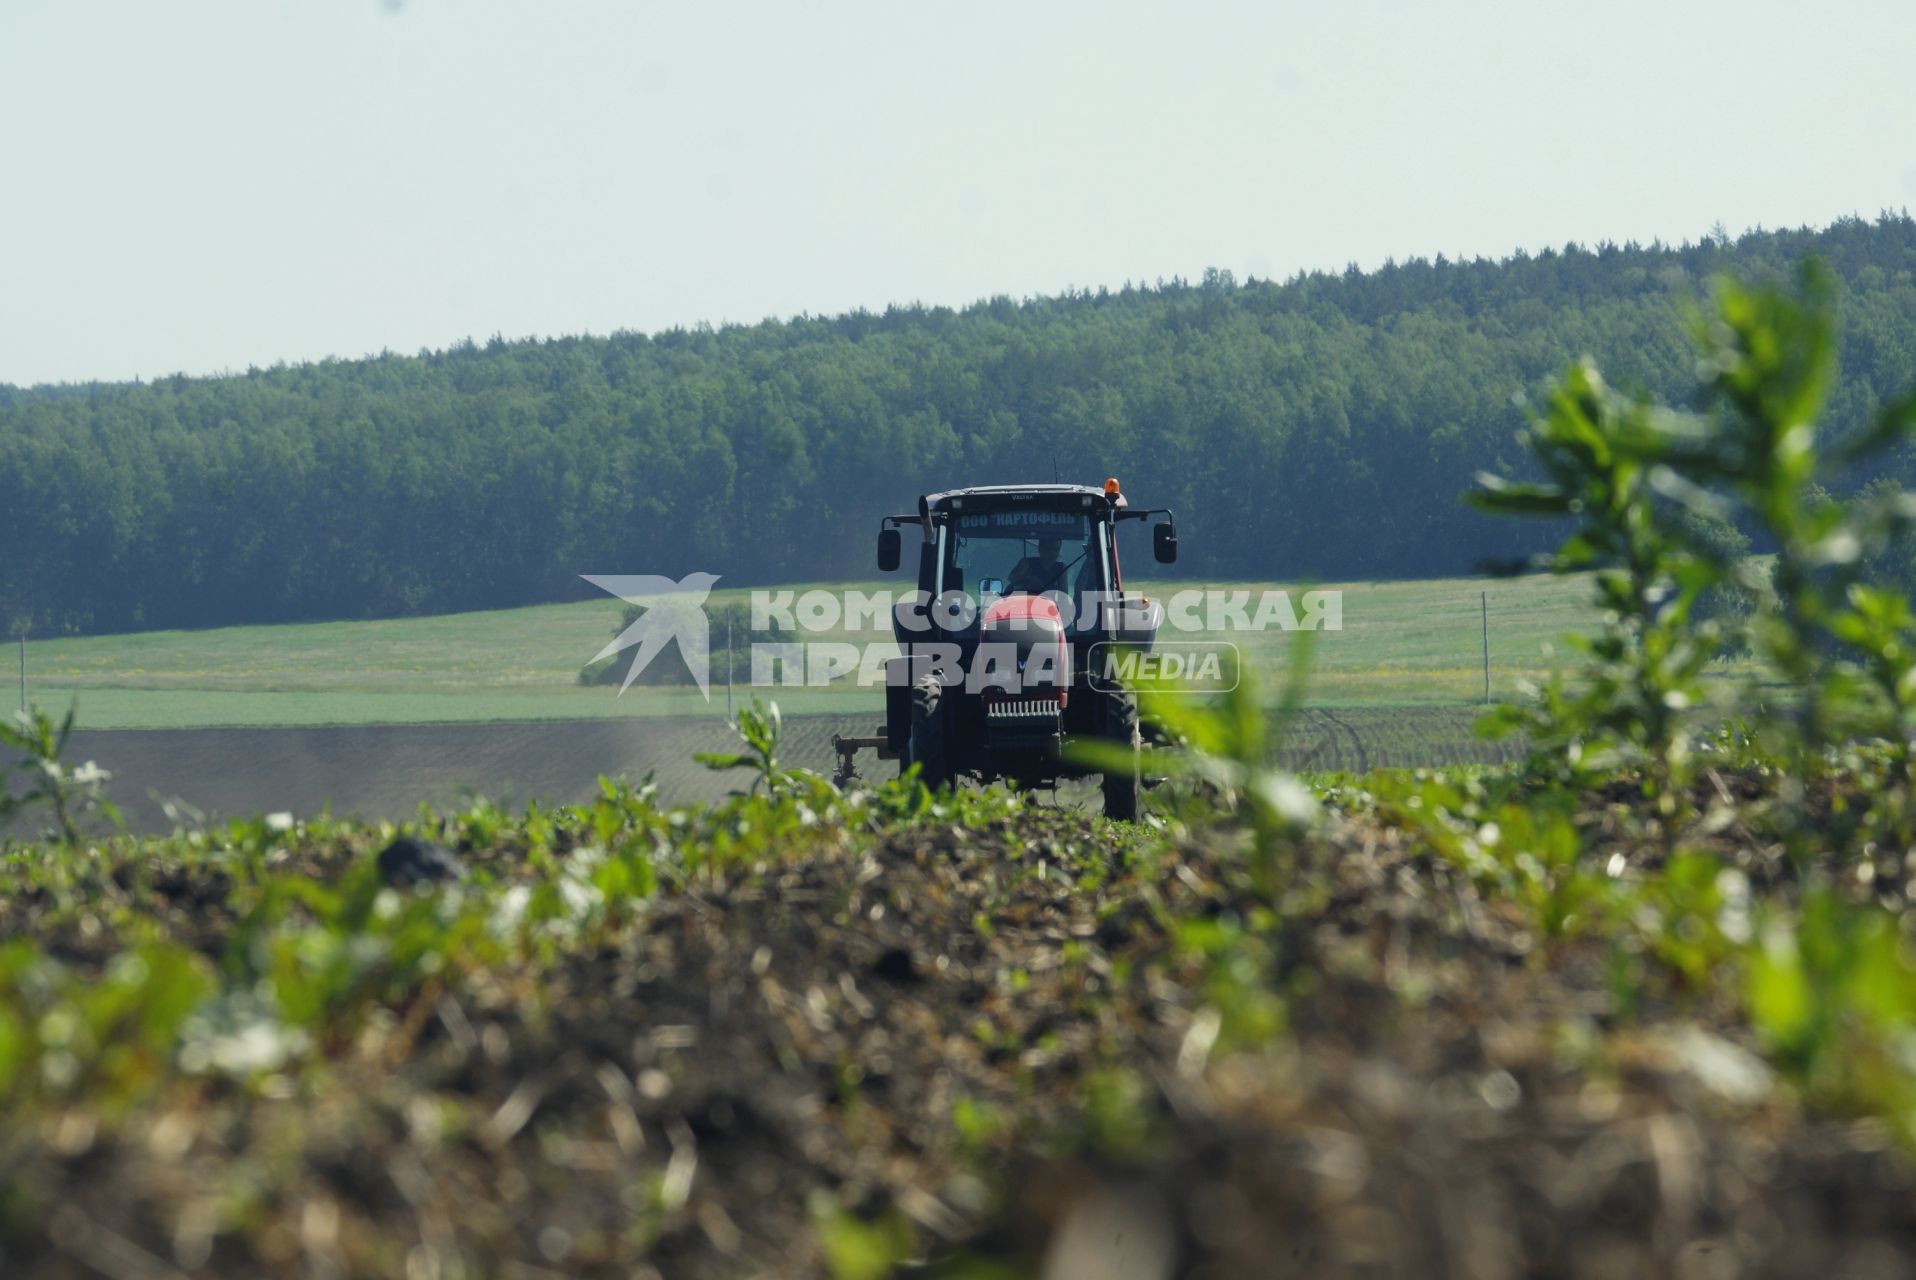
[0,781,1916,1280]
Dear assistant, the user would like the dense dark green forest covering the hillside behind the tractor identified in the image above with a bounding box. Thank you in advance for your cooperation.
[0,215,1916,632]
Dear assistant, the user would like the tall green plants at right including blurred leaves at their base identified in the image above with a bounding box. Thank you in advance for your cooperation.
[1456,263,1916,1142]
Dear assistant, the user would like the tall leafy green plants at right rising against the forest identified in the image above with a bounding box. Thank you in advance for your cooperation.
[1471,263,1916,839]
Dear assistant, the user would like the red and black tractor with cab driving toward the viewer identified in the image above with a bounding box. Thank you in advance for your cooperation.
[870,479,1178,820]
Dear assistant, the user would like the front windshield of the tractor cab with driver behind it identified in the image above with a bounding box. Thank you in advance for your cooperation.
[941,512,1107,630]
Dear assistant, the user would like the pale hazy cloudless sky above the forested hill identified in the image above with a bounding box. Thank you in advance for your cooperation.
[0,0,1916,383]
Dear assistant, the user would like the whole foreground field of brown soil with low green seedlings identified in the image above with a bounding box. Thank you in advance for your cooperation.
[0,768,1916,1280]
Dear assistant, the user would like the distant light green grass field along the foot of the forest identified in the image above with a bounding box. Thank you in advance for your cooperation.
[7,577,1739,728]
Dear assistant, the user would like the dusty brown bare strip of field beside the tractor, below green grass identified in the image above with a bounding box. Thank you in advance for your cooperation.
[7,707,1516,832]
